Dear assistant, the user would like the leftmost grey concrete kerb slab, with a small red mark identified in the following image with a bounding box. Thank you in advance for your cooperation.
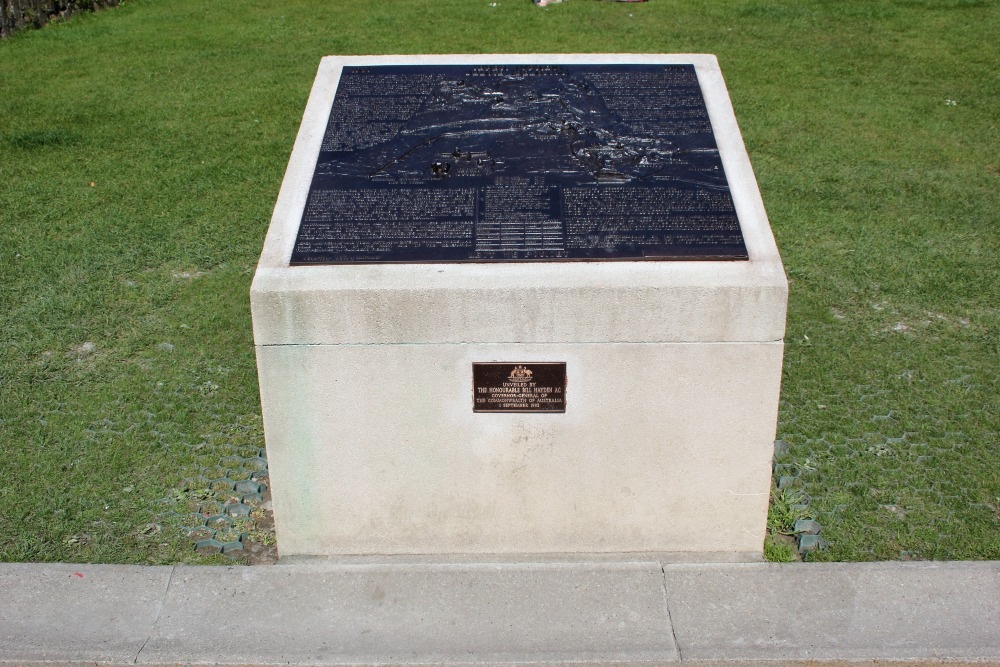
[0,563,173,663]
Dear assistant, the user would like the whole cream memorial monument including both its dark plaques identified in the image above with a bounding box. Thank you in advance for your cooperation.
[251,55,787,559]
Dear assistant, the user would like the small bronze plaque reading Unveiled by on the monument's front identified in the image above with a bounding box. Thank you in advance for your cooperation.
[472,361,566,412]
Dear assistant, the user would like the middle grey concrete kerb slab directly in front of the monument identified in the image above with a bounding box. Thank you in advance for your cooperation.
[137,561,678,665]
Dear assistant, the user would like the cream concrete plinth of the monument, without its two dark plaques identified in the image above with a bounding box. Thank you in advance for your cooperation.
[251,55,787,556]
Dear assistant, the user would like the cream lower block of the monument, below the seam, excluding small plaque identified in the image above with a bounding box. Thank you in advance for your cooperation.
[258,343,782,556]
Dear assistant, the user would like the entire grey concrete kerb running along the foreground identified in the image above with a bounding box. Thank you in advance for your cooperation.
[0,554,1000,665]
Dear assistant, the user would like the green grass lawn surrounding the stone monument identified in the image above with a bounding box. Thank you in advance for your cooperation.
[0,0,1000,563]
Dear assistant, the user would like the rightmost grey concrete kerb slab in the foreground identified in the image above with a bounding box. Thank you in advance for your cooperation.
[664,562,1000,661]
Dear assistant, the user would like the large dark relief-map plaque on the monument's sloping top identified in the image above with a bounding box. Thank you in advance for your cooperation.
[291,65,747,265]
